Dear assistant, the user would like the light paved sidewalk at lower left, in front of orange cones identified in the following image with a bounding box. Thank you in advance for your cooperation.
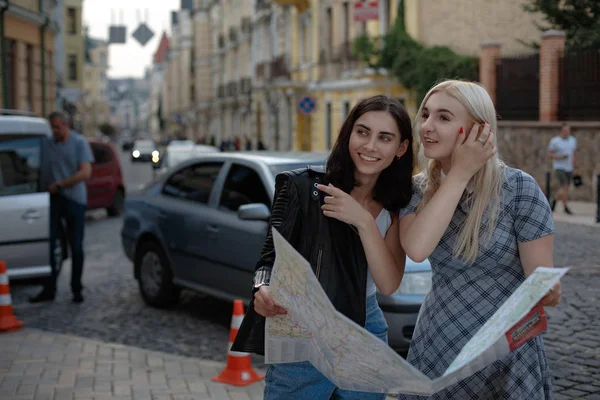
[0,329,264,400]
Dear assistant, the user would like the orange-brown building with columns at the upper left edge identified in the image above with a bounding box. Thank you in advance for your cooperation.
[0,0,58,115]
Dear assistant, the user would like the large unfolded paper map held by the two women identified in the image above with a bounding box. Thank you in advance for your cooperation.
[265,229,568,396]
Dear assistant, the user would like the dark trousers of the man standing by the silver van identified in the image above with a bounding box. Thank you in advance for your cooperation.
[44,194,87,295]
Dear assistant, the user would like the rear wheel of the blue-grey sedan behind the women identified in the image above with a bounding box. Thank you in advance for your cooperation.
[136,241,180,308]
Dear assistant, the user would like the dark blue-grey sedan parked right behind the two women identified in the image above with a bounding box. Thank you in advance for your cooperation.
[121,152,431,351]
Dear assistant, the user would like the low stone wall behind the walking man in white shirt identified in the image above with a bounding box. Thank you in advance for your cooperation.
[498,121,600,201]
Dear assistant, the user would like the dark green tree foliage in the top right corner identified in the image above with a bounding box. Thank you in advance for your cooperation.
[523,0,600,50]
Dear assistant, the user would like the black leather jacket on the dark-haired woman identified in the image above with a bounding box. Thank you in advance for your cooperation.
[232,168,367,355]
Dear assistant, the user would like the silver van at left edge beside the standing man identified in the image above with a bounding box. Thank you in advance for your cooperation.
[0,110,52,279]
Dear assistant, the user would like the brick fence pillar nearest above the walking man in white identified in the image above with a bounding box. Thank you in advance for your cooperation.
[539,30,565,121]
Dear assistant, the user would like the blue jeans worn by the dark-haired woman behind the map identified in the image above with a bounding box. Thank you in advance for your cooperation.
[264,296,388,400]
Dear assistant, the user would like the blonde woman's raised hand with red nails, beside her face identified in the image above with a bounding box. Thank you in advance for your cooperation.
[449,122,497,181]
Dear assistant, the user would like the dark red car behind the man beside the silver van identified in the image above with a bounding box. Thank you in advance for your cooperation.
[86,139,125,216]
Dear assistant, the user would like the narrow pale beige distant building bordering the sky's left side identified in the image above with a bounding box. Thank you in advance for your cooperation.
[79,37,110,136]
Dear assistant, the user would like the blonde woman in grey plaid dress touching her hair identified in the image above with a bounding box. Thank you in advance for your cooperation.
[400,80,561,400]
